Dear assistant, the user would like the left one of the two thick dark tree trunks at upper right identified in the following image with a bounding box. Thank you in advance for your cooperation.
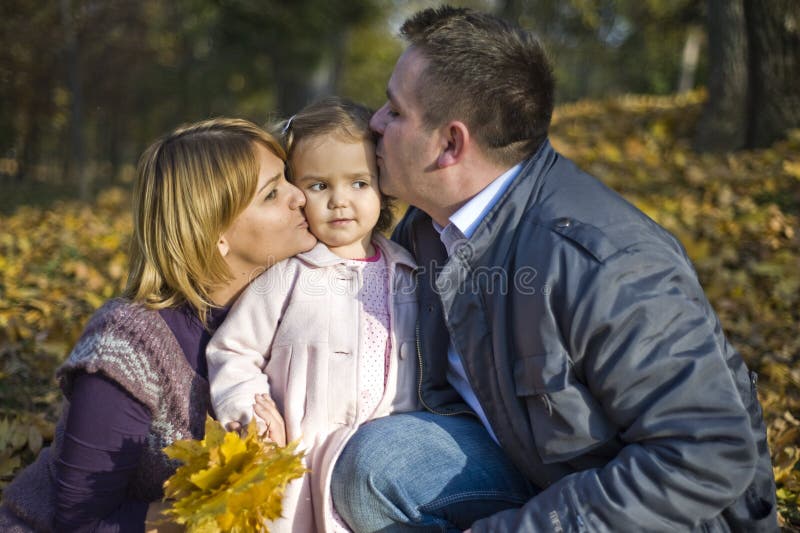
[694,0,752,152]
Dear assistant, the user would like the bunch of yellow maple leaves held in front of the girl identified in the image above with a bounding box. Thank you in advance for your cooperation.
[159,416,306,533]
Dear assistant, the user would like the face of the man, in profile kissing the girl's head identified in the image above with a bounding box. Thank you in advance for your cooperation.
[370,47,439,209]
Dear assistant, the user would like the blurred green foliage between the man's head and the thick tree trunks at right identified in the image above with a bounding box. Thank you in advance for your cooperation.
[505,0,704,102]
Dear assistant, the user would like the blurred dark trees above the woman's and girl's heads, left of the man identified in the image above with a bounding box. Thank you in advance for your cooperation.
[0,0,396,191]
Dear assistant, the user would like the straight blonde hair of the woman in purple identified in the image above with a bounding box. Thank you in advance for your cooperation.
[123,118,286,323]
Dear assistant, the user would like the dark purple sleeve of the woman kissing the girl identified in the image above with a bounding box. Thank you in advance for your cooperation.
[54,373,151,532]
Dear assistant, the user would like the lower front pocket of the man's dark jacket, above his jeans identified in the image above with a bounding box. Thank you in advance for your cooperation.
[514,352,617,463]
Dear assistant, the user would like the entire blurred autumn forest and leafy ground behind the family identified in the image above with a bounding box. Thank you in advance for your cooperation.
[0,0,800,529]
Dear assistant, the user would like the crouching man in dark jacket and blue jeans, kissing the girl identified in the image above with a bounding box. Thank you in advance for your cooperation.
[332,7,777,532]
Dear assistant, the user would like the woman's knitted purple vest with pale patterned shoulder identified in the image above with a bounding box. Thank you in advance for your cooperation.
[3,299,210,531]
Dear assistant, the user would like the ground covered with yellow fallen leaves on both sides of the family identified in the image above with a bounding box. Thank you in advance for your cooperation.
[0,93,800,529]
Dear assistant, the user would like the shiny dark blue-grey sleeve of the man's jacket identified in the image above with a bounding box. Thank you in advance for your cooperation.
[473,244,757,533]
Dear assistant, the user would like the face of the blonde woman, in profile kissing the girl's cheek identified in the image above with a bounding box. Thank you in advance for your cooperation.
[219,144,317,279]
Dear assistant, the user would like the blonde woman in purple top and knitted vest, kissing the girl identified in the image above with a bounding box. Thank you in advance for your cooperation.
[0,119,316,531]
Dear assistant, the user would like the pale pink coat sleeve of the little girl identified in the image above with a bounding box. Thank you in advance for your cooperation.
[206,262,291,425]
